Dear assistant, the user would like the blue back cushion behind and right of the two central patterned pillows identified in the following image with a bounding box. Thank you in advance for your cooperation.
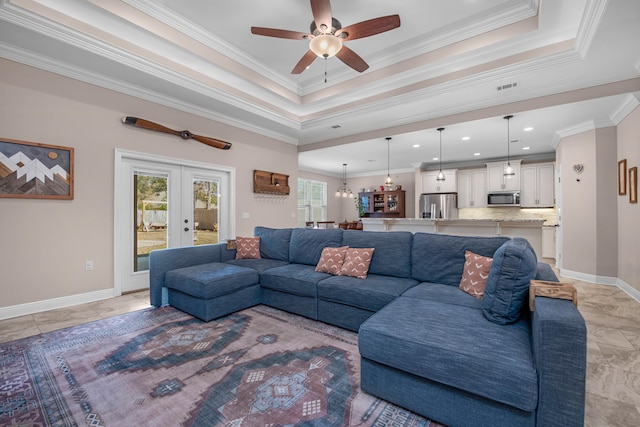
[342,230,413,277]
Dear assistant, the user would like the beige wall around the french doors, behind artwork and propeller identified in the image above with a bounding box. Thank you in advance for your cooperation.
[0,60,298,308]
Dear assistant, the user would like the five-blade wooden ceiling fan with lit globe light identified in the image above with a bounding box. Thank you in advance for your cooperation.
[251,0,400,74]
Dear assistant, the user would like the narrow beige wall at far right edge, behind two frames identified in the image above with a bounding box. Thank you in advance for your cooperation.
[616,107,640,291]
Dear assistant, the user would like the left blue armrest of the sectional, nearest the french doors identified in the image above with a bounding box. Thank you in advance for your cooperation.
[149,243,235,307]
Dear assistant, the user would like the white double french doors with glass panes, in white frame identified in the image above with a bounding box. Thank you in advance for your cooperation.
[114,150,234,293]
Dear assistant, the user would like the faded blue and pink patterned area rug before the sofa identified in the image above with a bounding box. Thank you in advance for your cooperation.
[0,306,440,427]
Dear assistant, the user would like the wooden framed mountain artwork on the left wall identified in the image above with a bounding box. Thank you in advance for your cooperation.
[0,138,73,200]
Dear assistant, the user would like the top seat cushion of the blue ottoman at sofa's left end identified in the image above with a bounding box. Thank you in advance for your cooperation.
[165,262,260,299]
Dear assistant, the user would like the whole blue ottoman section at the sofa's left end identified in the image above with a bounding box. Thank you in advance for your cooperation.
[165,262,261,322]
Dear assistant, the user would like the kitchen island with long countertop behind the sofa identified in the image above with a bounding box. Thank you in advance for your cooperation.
[361,218,545,258]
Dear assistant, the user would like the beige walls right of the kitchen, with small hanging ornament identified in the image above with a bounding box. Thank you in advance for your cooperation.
[557,121,640,290]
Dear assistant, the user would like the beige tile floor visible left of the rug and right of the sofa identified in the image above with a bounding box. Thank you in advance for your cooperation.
[0,278,640,427]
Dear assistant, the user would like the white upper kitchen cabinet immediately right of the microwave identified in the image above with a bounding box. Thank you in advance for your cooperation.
[520,163,555,208]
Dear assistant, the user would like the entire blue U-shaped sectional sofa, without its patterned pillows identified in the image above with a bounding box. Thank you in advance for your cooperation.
[150,227,586,426]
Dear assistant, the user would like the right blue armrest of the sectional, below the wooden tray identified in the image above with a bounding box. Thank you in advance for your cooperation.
[531,297,587,426]
